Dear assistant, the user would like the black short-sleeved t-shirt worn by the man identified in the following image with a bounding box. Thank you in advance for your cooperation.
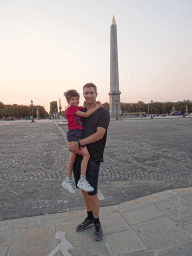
[82,108,110,162]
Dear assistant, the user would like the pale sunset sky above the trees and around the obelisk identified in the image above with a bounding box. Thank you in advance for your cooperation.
[0,0,192,111]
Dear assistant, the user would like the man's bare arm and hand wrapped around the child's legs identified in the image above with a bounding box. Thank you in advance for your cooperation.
[69,127,106,152]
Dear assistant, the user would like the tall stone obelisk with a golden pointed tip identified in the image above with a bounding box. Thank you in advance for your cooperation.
[109,16,121,119]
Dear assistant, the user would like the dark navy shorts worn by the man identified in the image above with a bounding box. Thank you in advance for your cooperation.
[73,156,100,196]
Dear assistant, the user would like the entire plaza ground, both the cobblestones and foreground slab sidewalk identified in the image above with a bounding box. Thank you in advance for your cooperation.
[0,118,192,256]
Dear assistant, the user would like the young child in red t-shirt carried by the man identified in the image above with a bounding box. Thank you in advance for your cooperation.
[62,90,101,193]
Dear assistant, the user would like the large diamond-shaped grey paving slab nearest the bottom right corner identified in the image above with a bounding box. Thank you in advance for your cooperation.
[132,217,191,250]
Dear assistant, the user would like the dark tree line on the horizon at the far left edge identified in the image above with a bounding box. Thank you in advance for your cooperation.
[0,102,49,118]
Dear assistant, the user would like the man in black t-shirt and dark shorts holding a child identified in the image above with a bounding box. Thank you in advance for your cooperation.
[69,83,110,241]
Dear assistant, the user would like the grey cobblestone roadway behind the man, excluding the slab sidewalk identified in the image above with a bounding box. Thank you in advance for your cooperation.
[0,118,192,219]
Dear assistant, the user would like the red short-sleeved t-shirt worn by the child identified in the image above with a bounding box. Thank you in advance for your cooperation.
[66,106,83,130]
